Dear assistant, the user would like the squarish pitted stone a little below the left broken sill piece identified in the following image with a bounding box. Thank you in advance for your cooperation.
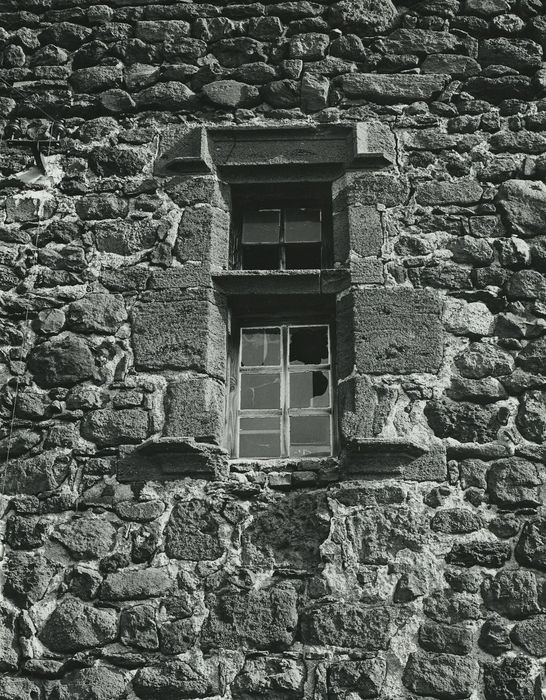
[165,499,224,561]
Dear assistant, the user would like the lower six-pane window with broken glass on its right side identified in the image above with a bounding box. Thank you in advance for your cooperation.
[228,324,333,459]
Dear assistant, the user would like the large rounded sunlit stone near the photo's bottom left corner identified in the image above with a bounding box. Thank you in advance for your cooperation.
[40,598,118,653]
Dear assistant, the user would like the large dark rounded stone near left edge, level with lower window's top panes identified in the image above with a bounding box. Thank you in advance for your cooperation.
[29,333,95,388]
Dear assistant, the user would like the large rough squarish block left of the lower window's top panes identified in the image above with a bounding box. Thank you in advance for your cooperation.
[132,290,226,380]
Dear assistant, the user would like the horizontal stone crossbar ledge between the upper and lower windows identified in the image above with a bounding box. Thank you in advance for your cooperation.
[212,269,350,296]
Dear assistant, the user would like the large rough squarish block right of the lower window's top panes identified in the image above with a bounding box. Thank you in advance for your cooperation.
[338,289,443,377]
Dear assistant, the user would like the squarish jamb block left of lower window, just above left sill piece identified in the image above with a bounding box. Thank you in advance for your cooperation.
[164,377,225,442]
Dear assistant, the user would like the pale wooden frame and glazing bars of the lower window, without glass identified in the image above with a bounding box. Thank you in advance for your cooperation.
[226,312,337,462]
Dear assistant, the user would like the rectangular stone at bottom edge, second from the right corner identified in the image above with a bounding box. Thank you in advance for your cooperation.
[403,652,480,700]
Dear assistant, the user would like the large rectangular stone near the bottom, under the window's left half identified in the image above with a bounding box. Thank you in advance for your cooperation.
[201,586,298,651]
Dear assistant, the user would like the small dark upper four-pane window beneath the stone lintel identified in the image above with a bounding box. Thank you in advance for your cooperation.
[227,183,331,270]
